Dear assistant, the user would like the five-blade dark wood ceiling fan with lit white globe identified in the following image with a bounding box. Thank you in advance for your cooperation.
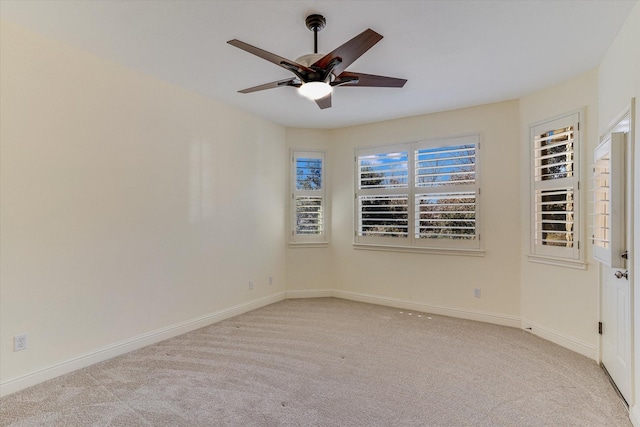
[227,14,407,109]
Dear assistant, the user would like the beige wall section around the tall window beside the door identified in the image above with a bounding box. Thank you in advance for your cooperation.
[519,70,599,359]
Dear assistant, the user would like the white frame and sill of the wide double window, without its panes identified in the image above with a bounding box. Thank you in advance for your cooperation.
[353,134,484,256]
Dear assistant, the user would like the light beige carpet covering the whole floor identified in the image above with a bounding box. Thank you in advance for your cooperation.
[0,298,631,427]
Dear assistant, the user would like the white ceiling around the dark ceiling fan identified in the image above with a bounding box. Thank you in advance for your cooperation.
[0,0,636,128]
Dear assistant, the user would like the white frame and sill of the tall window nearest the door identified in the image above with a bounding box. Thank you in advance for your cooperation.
[528,110,586,269]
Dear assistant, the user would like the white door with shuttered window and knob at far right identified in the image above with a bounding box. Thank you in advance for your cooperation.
[594,112,633,404]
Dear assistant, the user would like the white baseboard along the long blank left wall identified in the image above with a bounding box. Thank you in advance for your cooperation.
[0,292,286,396]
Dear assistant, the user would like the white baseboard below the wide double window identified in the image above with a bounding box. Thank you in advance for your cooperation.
[331,291,520,328]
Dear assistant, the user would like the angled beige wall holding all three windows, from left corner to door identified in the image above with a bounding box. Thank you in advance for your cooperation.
[287,70,599,359]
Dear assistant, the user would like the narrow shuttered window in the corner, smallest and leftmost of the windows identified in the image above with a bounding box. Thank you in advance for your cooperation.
[291,151,326,243]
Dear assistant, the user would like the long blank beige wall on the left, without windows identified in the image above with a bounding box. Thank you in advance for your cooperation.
[0,22,288,390]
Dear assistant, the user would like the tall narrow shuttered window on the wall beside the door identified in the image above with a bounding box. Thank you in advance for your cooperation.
[530,113,582,262]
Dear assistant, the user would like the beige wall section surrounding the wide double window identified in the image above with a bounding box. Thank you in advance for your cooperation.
[320,101,520,322]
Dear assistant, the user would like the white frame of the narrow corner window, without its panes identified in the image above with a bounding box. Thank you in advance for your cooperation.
[289,149,329,247]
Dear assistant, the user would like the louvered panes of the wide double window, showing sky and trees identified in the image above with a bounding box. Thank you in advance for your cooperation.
[358,144,476,239]
